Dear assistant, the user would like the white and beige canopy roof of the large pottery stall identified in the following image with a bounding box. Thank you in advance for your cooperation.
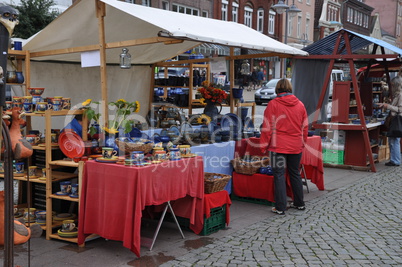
[24,0,308,64]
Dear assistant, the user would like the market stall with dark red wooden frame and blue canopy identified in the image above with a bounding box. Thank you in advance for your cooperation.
[293,29,402,172]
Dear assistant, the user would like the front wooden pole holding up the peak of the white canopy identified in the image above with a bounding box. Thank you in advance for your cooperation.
[95,0,109,127]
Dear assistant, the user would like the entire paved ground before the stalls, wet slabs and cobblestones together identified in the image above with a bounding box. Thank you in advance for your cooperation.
[0,163,402,267]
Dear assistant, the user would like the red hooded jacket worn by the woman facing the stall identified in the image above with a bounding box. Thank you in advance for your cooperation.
[260,93,308,154]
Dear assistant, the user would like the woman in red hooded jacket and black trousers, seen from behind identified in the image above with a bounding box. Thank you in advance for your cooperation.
[260,78,308,215]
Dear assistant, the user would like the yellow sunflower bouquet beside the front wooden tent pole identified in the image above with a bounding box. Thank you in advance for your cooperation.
[103,99,140,134]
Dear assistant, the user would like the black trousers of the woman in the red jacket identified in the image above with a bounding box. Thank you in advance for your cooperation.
[270,152,304,214]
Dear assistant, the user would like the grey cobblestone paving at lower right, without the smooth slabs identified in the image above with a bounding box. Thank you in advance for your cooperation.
[161,168,402,267]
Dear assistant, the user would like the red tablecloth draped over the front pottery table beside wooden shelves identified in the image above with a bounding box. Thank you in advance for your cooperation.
[78,157,204,256]
